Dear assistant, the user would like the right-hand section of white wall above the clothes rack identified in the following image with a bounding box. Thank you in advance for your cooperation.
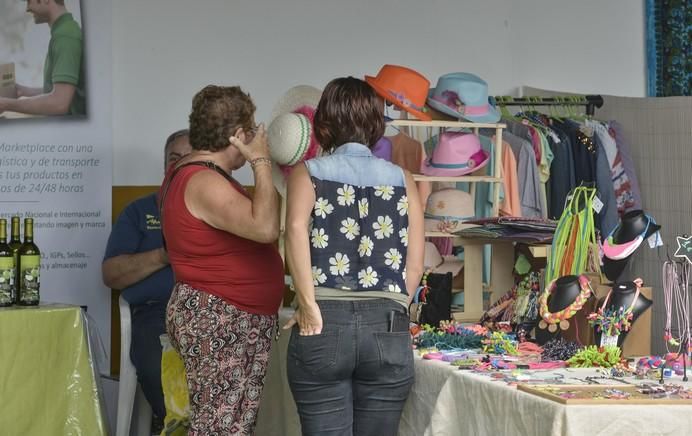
[510,0,646,97]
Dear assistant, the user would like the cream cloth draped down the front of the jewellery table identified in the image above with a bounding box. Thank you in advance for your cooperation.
[399,358,692,436]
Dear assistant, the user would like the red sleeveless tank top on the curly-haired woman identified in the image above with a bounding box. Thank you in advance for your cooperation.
[159,165,284,315]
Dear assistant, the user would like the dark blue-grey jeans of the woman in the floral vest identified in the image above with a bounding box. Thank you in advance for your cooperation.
[287,299,414,436]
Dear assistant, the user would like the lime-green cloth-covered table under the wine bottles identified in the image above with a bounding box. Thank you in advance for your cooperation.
[0,304,107,436]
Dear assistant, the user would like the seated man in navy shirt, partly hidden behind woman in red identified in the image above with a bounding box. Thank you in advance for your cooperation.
[101,130,192,420]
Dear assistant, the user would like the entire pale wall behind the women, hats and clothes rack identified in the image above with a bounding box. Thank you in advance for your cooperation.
[113,0,644,185]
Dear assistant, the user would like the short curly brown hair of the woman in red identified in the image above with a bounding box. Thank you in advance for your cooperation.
[190,85,255,151]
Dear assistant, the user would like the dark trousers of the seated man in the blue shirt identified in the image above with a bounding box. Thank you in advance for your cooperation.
[130,302,167,419]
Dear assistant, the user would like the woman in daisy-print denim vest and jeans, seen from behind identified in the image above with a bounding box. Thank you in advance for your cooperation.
[286,77,424,436]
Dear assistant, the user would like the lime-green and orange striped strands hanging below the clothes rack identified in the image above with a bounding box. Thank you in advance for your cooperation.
[545,186,600,282]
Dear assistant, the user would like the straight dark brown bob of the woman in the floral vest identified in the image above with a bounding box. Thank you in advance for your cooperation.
[315,76,384,151]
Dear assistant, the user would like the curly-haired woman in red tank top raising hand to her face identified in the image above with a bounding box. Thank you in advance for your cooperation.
[160,85,284,435]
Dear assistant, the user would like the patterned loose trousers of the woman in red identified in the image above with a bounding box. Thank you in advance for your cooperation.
[166,283,277,436]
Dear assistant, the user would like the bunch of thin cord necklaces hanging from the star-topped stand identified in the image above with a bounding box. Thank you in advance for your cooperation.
[662,260,692,355]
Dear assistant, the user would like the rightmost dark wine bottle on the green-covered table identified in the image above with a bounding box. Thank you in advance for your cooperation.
[19,218,41,306]
